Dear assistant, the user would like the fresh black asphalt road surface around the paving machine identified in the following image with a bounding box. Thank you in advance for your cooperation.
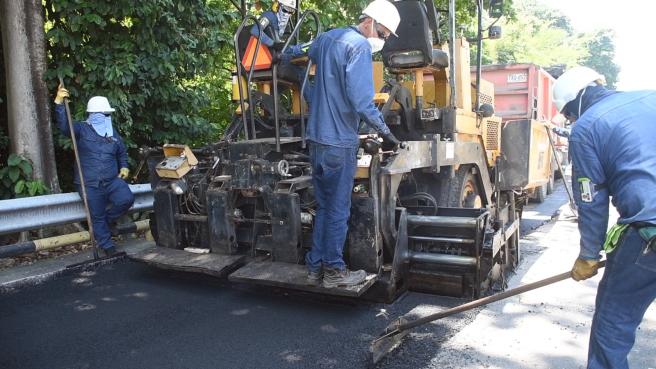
[0,186,566,369]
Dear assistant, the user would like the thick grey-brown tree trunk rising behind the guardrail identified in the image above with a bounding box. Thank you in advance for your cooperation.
[0,0,60,192]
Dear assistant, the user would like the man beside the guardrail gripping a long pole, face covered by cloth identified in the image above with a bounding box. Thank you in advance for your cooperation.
[55,86,134,256]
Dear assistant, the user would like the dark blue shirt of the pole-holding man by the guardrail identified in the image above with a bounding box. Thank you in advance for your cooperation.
[55,104,128,187]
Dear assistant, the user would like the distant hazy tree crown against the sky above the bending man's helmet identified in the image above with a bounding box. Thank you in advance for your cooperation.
[579,29,620,89]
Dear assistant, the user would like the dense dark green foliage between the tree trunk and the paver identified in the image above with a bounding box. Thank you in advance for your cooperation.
[46,0,236,147]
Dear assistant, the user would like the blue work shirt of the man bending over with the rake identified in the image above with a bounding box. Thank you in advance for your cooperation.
[569,91,656,259]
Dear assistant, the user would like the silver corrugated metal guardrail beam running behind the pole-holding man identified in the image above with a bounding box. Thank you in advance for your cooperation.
[0,183,153,235]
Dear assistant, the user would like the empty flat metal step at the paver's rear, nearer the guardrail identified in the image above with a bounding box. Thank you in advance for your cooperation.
[129,246,246,277]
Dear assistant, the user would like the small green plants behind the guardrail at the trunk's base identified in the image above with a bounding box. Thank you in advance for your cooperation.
[0,154,49,200]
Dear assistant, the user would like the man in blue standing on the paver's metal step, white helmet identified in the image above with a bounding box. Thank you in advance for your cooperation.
[289,0,400,288]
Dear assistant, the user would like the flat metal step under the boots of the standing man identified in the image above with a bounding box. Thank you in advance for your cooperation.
[228,261,378,297]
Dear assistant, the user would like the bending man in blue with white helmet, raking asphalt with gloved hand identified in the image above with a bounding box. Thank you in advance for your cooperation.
[553,67,656,369]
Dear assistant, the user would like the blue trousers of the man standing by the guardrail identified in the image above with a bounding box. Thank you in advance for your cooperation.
[78,177,134,249]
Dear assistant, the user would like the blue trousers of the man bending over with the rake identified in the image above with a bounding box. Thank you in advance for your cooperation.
[588,227,656,369]
